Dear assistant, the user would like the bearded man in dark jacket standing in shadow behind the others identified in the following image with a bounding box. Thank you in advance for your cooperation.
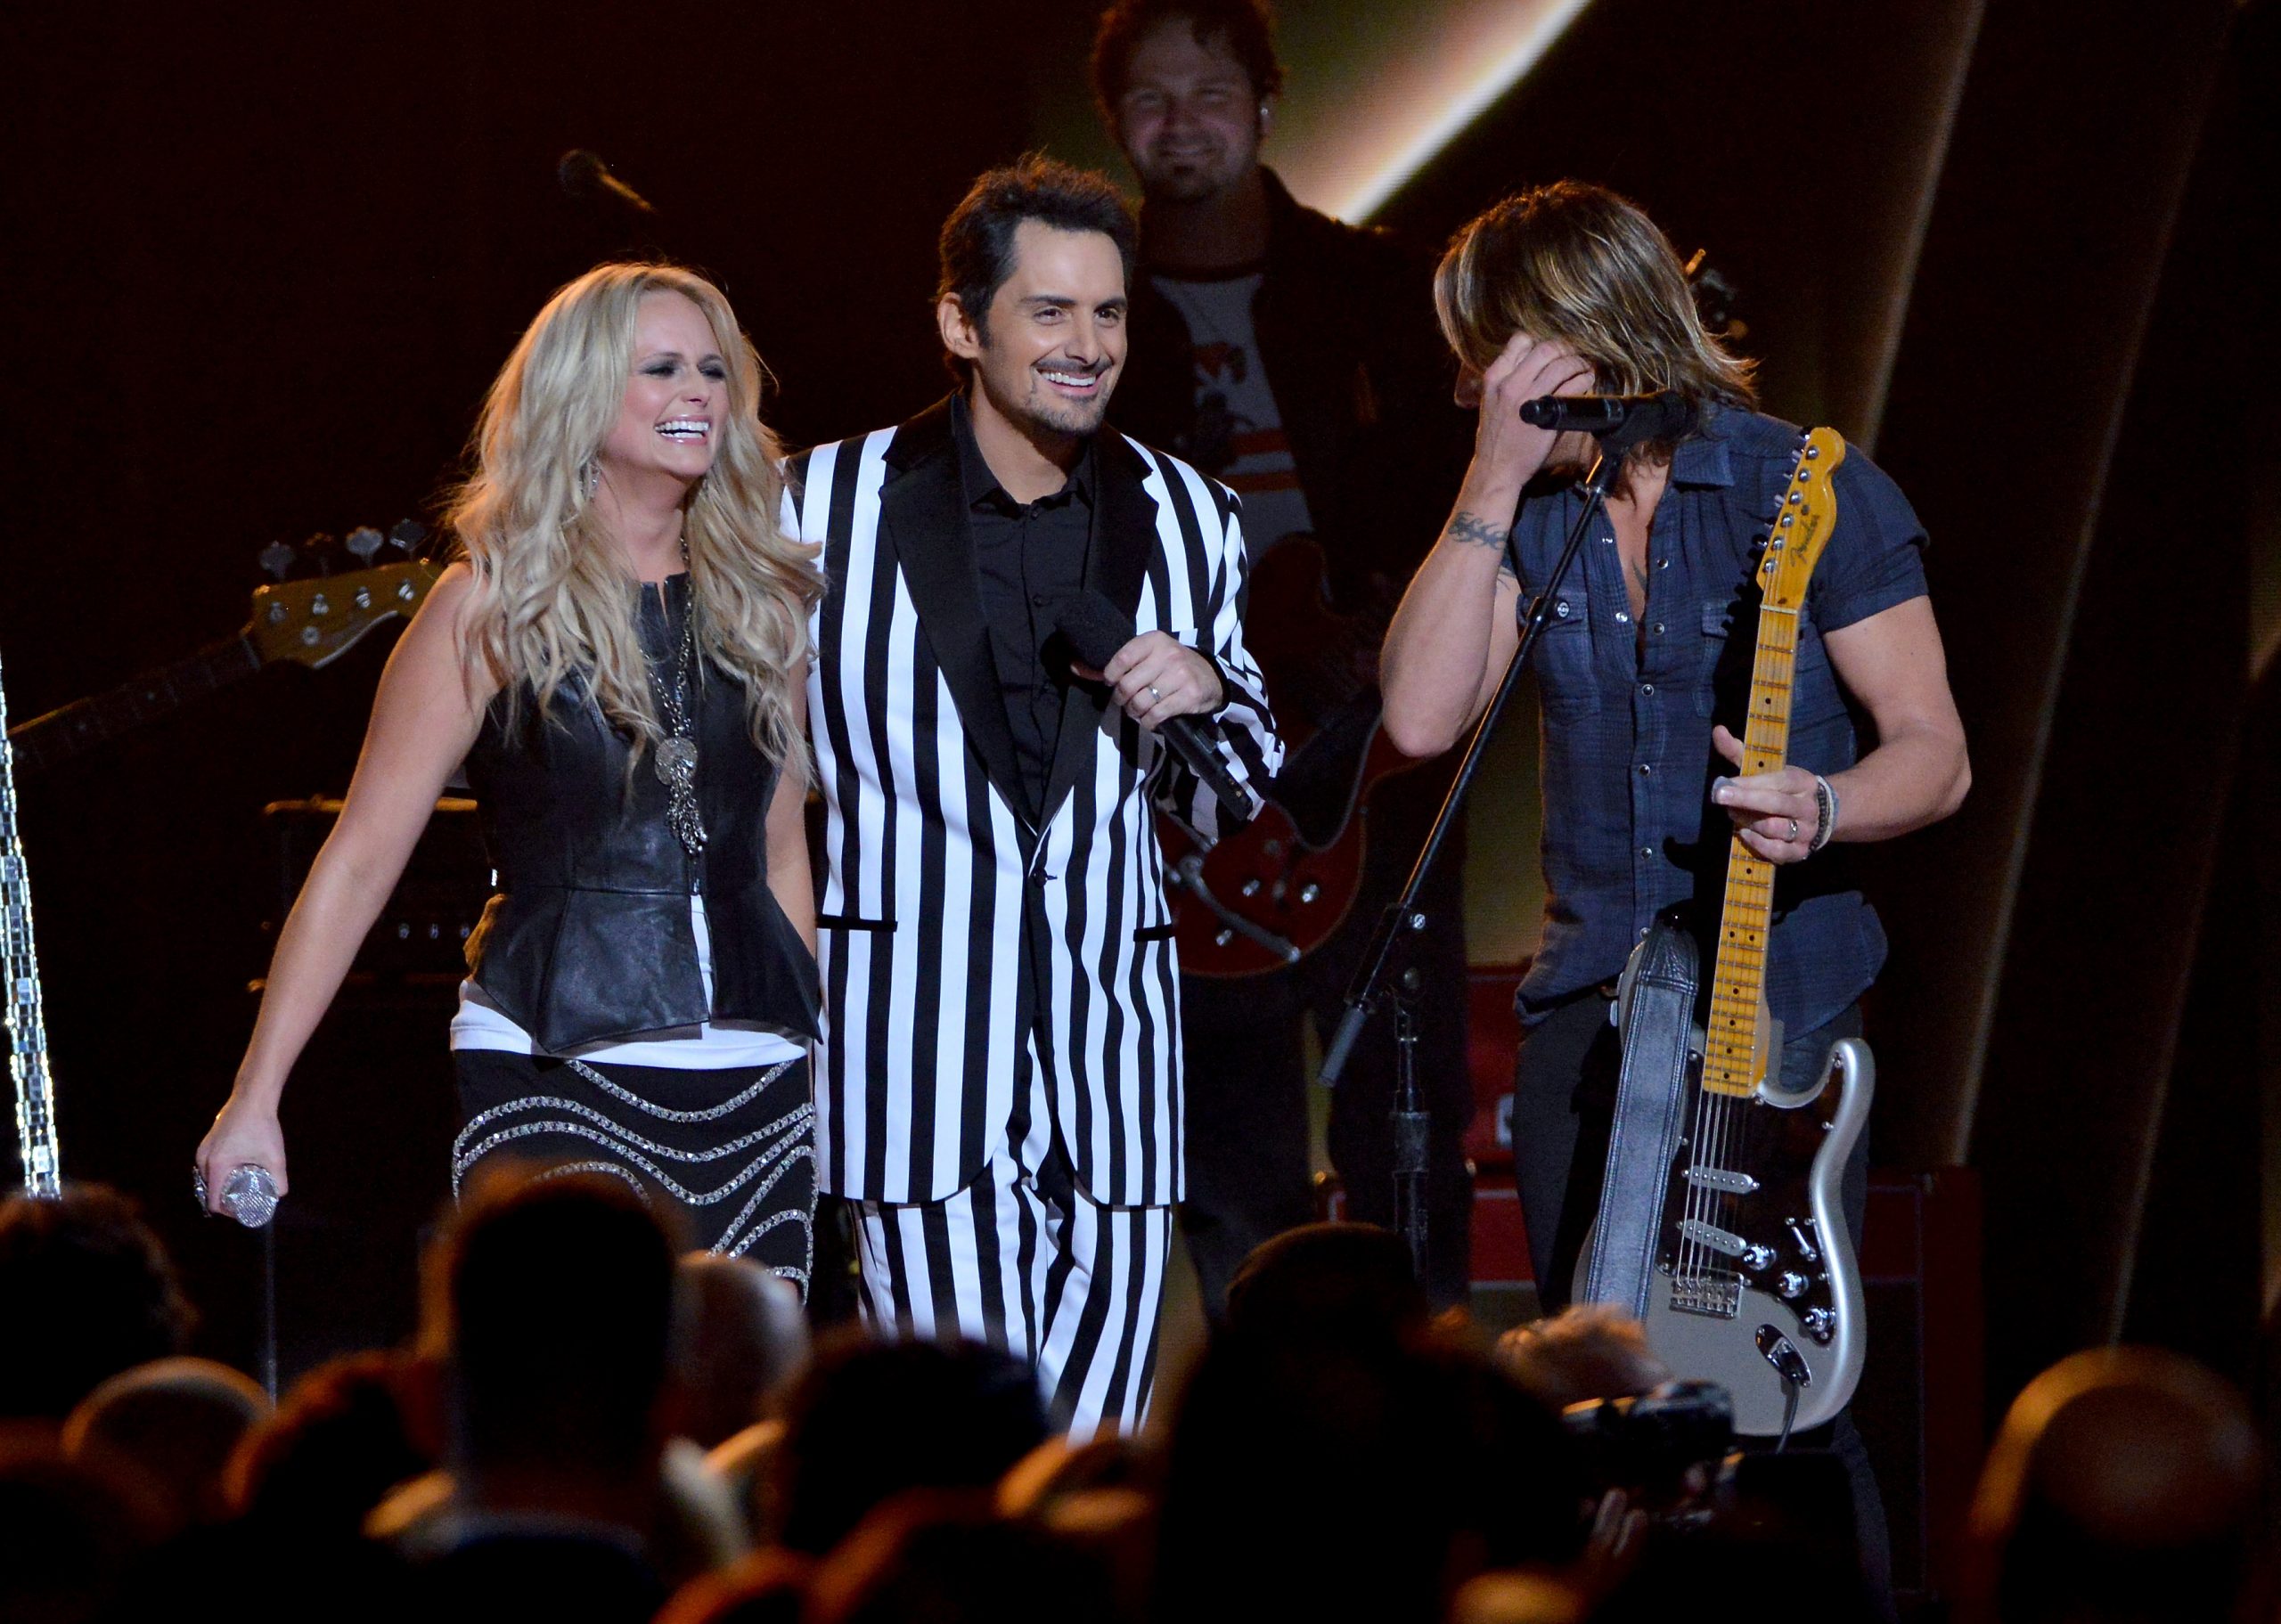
[1092,0,1474,1314]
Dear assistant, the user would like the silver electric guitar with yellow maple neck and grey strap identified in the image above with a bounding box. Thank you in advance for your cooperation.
[1576,428,1875,1437]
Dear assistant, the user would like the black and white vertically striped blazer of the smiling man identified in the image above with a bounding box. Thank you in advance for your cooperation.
[785,402,1282,1206]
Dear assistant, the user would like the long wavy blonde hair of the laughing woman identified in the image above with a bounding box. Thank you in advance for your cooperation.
[447,265,823,787]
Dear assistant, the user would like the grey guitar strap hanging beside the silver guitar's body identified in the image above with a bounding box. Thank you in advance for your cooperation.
[1581,917,1699,1318]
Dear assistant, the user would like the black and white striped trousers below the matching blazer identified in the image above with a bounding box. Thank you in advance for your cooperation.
[855,1040,1173,1440]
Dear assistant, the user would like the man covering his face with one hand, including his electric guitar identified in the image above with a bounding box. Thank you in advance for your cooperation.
[1382,183,1971,1614]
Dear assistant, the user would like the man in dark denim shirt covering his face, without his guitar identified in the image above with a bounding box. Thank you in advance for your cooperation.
[1382,180,1971,1583]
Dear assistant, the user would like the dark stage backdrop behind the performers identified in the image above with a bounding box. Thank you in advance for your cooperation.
[0,0,2281,1578]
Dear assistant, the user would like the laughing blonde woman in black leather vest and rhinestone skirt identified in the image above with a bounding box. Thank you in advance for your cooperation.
[199,265,822,1289]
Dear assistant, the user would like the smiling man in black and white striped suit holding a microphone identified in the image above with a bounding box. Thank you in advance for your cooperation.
[787,159,1282,1434]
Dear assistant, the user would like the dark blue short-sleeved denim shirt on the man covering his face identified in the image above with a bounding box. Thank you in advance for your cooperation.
[1510,406,1925,1035]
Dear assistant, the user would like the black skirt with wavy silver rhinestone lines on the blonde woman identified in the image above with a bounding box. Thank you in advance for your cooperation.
[452,1049,816,1298]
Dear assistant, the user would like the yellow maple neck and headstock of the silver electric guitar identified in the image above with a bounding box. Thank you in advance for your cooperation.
[1702,428,1845,1098]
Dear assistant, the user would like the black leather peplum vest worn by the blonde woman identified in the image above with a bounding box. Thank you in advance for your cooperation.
[465,575,819,1054]
